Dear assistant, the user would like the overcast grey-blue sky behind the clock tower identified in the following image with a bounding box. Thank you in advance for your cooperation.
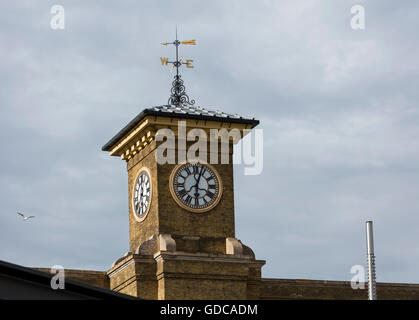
[0,0,419,283]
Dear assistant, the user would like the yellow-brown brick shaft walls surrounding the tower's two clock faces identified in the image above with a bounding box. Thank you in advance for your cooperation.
[127,141,235,252]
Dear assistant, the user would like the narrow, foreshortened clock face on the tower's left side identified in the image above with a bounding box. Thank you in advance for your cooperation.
[132,168,151,221]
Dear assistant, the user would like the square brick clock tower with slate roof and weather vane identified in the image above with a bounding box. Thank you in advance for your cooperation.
[102,40,265,300]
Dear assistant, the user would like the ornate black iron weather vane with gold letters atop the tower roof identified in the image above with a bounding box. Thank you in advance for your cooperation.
[160,28,196,106]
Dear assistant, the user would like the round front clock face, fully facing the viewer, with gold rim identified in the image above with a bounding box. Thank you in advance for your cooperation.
[170,163,222,212]
